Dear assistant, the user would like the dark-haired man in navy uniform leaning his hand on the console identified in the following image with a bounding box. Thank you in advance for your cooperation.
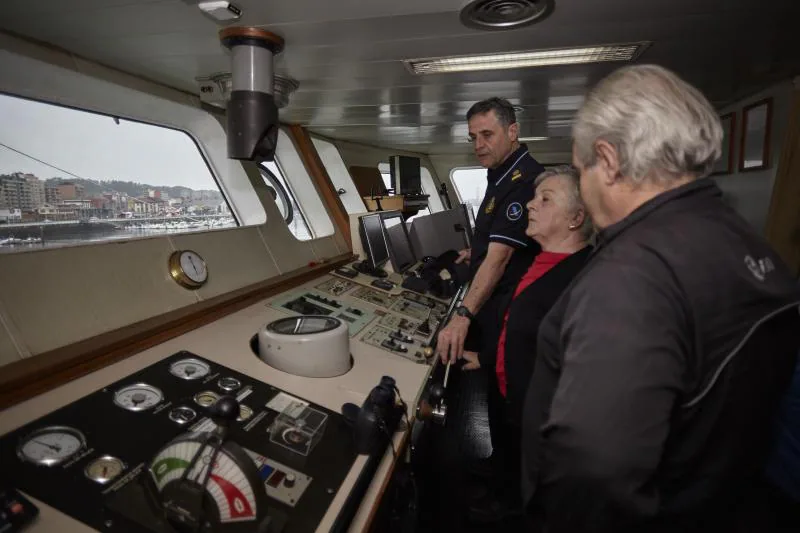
[436,98,544,474]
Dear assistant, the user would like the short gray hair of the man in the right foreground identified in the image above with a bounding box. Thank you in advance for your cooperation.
[572,65,722,184]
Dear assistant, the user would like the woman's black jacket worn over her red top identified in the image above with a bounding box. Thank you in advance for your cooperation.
[495,246,592,424]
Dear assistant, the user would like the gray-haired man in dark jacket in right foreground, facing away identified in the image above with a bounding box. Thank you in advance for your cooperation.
[522,65,800,533]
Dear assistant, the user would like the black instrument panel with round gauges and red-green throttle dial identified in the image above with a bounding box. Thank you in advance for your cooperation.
[0,351,357,533]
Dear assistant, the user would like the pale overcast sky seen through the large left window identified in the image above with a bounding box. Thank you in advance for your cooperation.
[0,94,218,190]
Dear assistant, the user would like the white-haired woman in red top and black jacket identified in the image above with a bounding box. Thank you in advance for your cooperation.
[456,165,593,521]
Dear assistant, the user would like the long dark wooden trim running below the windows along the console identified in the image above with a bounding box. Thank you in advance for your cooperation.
[0,254,352,410]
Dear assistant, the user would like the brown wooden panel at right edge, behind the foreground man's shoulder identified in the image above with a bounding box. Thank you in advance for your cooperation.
[764,86,800,276]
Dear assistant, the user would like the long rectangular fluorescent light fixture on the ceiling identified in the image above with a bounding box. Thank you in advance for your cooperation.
[404,41,650,74]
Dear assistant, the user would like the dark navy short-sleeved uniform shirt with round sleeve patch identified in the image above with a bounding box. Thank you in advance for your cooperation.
[470,145,544,289]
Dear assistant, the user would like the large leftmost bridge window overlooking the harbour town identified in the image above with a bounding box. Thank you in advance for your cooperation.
[0,94,238,252]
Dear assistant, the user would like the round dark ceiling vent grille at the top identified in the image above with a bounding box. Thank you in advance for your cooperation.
[461,0,555,31]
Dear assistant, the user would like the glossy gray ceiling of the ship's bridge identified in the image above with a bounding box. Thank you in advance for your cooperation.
[0,0,800,152]
